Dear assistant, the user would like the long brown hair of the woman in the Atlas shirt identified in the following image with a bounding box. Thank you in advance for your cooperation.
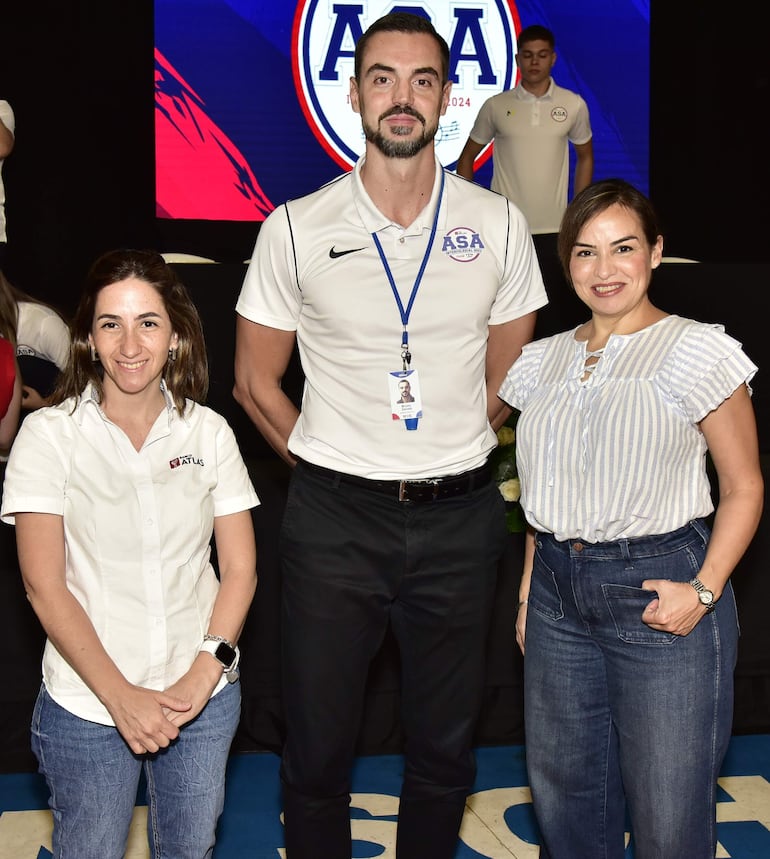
[51,250,209,414]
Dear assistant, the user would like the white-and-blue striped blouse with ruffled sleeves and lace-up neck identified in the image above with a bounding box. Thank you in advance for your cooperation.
[499,316,757,543]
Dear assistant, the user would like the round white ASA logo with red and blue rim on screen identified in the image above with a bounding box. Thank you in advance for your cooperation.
[291,0,520,170]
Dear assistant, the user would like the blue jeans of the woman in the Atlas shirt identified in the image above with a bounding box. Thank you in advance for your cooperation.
[32,683,241,859]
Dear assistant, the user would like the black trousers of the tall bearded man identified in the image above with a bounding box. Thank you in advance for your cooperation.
[281,462,505,859]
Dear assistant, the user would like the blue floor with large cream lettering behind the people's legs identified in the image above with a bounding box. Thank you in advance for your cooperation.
[0,735,770,859]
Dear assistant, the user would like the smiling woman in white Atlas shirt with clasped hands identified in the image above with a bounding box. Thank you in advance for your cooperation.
[0,251,259,859]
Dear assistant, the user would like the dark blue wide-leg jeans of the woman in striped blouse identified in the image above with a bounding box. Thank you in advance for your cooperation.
[524,521,739,859]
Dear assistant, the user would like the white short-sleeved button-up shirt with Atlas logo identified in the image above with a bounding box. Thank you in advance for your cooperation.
[0,382,259,725]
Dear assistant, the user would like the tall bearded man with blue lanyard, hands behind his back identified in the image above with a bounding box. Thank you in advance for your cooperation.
[234,8,546,859]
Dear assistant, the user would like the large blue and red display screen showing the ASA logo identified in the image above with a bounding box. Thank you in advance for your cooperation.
[155,0,649,221]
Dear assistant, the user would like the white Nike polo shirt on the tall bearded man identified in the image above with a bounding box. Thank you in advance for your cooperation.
[236,159,547,479]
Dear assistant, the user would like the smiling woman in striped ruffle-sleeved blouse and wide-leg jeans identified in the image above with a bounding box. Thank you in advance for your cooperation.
[499,179,763,859]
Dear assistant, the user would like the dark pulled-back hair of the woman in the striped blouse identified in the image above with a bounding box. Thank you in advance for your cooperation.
[558,179,661,284]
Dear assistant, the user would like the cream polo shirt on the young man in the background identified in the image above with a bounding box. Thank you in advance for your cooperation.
[470,78,592,234]
